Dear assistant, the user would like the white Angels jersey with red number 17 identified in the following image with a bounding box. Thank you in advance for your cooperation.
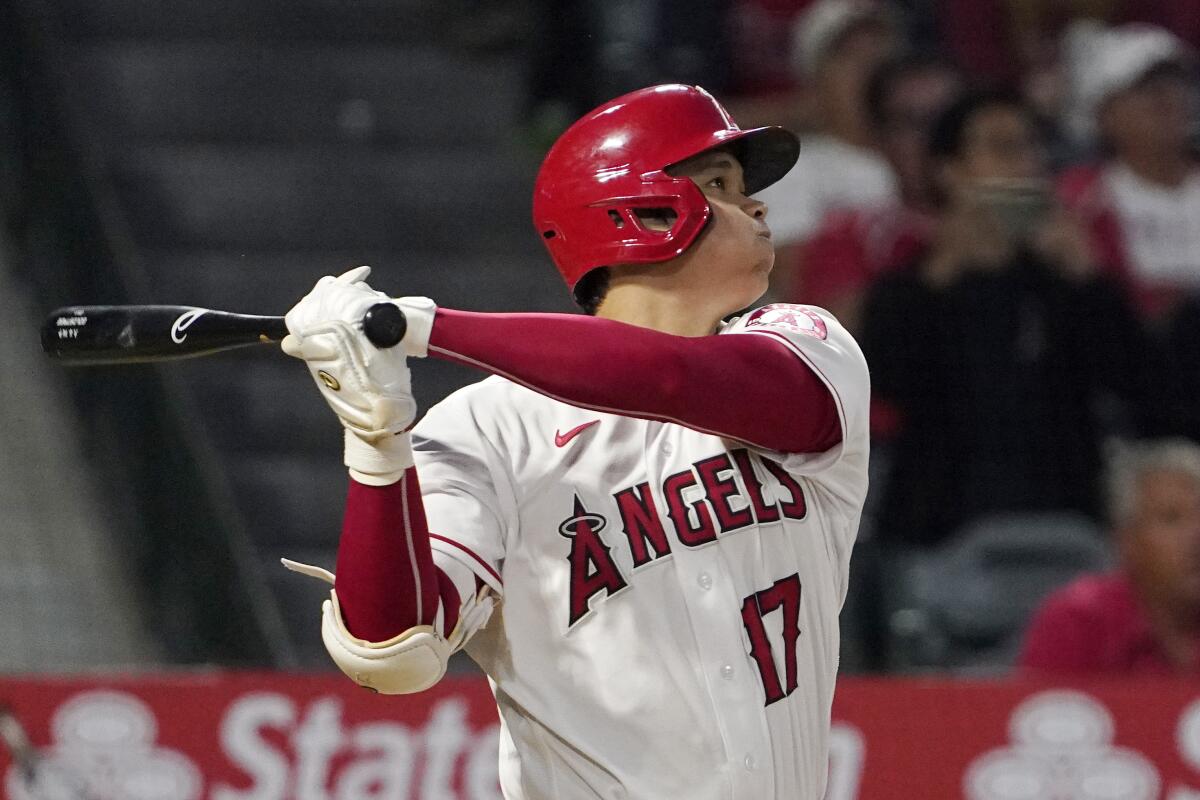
[414,305,869,800]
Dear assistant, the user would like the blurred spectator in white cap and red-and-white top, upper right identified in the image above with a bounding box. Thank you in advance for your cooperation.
[1062,25,1200,319]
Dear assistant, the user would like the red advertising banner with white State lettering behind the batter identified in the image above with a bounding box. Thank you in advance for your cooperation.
[0,672,1200,800]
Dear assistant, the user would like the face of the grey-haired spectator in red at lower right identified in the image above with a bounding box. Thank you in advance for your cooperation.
[1122,470,1200,613]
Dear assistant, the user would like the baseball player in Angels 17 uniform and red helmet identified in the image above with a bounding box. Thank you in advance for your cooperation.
[284,85,869,800]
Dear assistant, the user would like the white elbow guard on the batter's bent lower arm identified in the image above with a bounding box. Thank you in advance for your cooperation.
[320,590,451,694]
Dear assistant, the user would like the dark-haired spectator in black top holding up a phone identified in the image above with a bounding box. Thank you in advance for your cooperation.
[859,92,1142,546]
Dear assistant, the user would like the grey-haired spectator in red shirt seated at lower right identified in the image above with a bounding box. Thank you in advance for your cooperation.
[1019,439,1200,675]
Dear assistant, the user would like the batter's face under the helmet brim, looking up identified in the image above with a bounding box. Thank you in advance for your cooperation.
[670,150,775,312]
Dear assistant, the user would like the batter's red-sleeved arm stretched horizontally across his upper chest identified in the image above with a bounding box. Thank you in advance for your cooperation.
[428,308,841,452]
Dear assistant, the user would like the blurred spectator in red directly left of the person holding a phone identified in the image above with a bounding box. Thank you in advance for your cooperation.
[792,54,962,333]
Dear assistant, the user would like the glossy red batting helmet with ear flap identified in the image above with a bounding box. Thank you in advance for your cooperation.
[533,84,800,299]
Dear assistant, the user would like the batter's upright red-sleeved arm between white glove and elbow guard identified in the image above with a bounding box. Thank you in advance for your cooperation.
[336,468,460,642]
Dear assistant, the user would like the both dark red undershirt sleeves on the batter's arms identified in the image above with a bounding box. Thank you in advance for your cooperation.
[337,309,841,642]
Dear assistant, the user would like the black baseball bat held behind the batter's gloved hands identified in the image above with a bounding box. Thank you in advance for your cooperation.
[42,302,408,365]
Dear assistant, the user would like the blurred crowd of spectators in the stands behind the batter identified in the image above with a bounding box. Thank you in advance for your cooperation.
[530,0,1200,674]
